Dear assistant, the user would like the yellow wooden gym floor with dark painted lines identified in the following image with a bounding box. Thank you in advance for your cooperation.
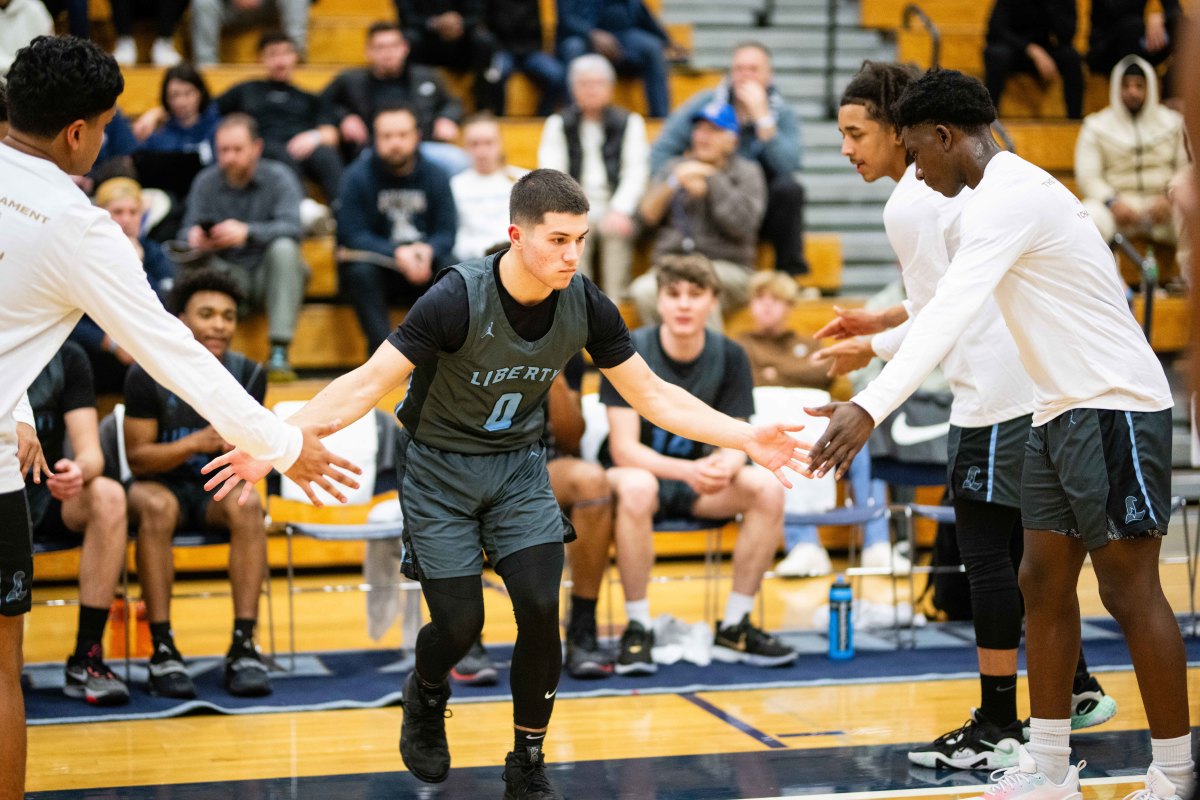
[18,554,1200,800]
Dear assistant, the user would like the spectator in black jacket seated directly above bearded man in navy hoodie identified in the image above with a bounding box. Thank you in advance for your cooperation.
[323,22,470,175]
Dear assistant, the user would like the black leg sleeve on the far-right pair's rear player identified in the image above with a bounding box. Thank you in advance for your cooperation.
[954,499,1024,650]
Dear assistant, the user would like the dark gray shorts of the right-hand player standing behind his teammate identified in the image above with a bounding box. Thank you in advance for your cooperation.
[946,414,1033,509]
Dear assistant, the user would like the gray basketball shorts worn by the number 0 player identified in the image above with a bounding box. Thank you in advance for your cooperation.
[396,432,565,579]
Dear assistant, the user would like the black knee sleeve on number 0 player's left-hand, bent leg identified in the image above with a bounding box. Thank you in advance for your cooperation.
[416,575,484,684]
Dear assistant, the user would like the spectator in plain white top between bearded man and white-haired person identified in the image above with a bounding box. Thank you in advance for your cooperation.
[450,114,529,261]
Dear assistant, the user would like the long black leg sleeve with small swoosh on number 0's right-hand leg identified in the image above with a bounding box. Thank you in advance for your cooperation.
[496,542,563,730]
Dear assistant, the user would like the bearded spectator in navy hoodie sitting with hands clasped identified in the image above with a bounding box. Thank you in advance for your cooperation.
[337,106,458,353]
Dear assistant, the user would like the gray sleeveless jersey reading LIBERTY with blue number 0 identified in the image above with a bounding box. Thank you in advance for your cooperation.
[413,258,588,453]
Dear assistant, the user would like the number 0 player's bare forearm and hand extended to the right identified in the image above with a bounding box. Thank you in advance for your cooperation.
[601,355,808,488]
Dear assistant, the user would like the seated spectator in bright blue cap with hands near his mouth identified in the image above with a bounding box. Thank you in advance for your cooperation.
[629,103,767,324]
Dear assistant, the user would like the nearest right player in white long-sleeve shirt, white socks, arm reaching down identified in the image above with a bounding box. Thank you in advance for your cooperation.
[810,71,1194,800]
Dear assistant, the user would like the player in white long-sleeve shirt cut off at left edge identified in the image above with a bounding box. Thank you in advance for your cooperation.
[0,36,356,800]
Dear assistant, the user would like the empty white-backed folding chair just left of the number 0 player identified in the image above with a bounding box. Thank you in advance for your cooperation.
[274,401,421,669]
